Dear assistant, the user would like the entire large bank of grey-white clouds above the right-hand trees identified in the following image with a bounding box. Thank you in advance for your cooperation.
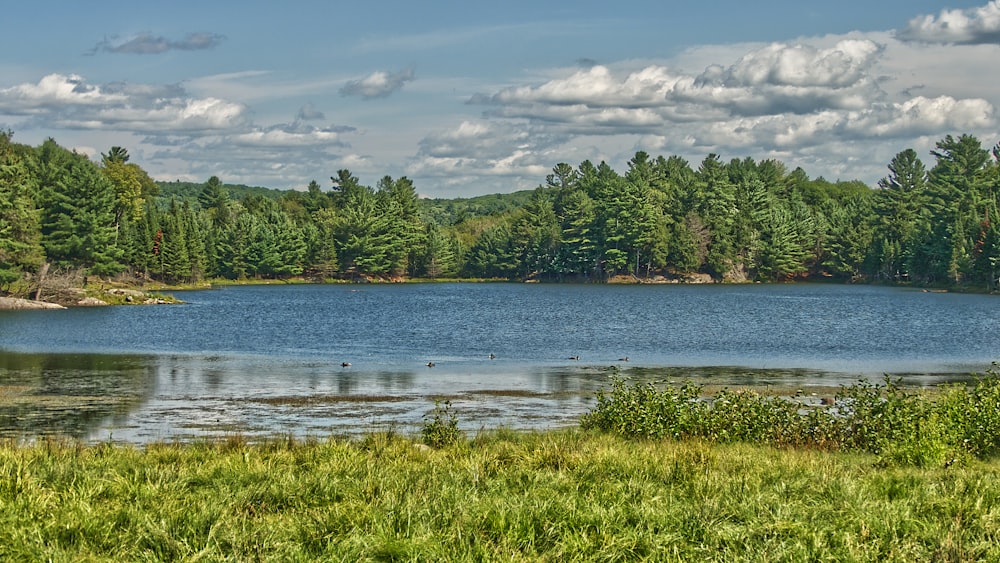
[430,32,1000,194]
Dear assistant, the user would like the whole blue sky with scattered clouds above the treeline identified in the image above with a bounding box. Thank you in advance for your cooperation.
[0,0,1000,198]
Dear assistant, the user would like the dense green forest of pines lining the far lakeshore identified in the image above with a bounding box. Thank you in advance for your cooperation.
[0,131,1000,296]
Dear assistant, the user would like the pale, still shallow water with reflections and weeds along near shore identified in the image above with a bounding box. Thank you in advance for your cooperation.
[0,352,984,444]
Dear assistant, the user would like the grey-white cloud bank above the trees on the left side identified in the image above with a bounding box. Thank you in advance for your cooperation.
[0,70,370,187]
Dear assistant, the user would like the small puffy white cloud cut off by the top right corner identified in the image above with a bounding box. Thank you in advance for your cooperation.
[896,0,1000,45]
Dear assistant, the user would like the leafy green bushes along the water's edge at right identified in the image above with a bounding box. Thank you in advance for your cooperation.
[582,367,1000,466]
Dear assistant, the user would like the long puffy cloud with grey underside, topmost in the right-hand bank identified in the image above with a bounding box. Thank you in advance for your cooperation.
[480,39,882,120]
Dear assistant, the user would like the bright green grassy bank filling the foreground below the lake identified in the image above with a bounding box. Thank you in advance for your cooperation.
[0,431,1000,561]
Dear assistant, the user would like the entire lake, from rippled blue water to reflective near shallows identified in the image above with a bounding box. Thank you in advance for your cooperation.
[0,284,1000,443]
